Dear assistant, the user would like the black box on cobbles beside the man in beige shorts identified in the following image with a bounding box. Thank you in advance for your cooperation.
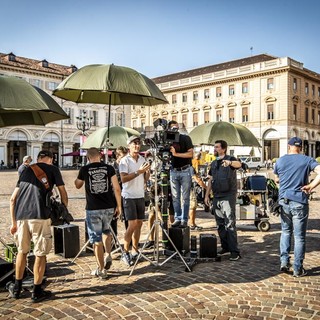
[53,224,80,258]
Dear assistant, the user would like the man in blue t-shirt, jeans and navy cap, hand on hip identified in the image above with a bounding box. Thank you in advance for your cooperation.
[274,137,320,277]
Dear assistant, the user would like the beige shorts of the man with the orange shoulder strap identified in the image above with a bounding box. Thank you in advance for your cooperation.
[16,219,52,257]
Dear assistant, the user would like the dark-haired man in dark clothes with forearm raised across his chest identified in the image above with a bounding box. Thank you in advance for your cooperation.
[204,140,241,261]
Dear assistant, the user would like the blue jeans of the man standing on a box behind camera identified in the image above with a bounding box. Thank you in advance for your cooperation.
[170,166,193,222]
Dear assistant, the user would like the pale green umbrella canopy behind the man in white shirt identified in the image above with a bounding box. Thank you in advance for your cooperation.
[81,126,140,149]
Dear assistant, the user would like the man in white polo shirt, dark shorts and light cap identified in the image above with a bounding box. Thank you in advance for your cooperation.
[119,136,150,266]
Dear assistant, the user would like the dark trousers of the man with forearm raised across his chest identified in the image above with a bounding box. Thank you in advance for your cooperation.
[212,194,240,254]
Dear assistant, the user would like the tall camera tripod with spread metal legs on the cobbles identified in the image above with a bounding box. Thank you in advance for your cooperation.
[130,139,191,276]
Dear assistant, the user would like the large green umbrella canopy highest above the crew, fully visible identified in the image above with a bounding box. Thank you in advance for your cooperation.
[53,64,168,106]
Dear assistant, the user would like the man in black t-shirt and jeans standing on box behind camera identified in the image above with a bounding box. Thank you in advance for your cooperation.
[168,120,193,228]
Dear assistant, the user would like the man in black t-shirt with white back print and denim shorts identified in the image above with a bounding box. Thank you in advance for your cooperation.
[74,148,121,279]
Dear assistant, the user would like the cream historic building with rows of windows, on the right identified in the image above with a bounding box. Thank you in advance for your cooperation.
[131,54,320,160]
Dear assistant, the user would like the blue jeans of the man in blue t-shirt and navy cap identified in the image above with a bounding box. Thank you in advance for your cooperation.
[279,199,309,271]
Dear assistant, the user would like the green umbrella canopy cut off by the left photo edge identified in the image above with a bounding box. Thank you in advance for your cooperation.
[0,76,69,127]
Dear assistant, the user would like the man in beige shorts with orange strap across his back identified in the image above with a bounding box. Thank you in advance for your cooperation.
[9,150,68,302]
